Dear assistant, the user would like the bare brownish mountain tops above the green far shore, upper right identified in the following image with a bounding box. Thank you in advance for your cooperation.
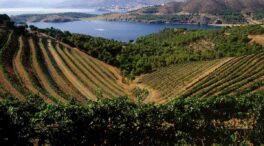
[138,0,264,15]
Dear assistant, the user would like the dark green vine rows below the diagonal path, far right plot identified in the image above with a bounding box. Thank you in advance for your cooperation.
[183,53,264,98]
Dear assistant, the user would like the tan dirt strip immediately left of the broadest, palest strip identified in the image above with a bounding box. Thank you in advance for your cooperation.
[39,40,85,102]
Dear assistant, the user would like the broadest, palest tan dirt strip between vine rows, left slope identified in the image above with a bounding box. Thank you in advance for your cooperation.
[48,40,96,99]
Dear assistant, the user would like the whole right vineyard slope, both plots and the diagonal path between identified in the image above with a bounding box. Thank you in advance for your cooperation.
[139,53,264,103]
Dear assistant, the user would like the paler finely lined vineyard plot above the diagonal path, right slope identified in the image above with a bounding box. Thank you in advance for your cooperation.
[139,59,229,102]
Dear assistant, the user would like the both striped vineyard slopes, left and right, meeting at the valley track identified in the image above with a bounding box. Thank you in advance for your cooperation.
[0,27,264,103]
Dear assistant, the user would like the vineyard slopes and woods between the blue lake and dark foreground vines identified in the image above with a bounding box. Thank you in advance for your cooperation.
[0,16,264,103]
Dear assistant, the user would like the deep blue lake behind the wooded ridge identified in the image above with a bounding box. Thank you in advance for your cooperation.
[29,20,219,42]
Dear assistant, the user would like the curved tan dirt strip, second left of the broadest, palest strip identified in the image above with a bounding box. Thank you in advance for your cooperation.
[29,38,65,102]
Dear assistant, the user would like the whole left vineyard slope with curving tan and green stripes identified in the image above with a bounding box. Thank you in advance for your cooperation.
[0,29,129,103]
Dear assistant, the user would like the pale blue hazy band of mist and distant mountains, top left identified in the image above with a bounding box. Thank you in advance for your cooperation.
[0,0,182,9]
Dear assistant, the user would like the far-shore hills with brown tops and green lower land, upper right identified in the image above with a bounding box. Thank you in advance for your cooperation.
[96,0,264,24]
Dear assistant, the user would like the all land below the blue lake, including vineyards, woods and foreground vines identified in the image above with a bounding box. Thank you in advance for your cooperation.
[0,15,264,146]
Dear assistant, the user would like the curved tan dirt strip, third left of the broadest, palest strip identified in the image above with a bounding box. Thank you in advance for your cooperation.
[14,37,52,103]
